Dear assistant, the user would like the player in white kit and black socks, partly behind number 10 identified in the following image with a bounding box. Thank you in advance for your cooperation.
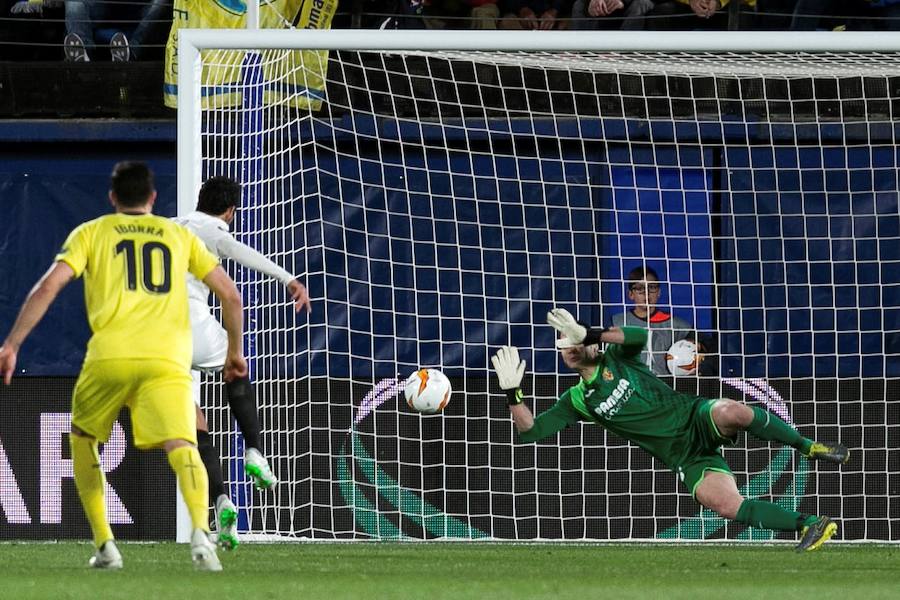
[175,177,311,550]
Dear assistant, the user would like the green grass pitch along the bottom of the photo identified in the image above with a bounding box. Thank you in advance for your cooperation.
[0,542,900,600]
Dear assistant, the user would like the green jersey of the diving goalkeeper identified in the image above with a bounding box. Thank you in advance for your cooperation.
[519,327,705,468]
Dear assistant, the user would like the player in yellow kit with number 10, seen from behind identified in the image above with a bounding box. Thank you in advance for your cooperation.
[0,162,247,571]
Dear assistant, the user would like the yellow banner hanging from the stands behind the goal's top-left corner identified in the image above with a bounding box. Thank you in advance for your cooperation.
[164,0,337,110]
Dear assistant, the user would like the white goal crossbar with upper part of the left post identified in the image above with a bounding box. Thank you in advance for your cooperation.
[177,29,900,213]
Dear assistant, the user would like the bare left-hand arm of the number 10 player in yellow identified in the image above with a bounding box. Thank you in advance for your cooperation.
[0,261,75,385]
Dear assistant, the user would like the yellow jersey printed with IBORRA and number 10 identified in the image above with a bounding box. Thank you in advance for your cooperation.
[56,213,219,369]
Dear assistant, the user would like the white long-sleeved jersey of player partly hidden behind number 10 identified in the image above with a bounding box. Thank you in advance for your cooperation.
[174,211,296,305]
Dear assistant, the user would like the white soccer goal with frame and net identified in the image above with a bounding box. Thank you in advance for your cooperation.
[178,30,900,541]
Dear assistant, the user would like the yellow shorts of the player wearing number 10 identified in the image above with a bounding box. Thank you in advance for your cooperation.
[72,359,197,449]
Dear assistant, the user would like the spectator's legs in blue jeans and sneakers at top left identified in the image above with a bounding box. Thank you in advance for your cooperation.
[63,0,172,62]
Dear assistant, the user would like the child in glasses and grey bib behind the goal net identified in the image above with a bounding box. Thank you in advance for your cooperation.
[609,267,716,375]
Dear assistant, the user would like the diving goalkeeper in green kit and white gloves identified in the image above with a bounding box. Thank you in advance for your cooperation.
[491,308,850,551]
